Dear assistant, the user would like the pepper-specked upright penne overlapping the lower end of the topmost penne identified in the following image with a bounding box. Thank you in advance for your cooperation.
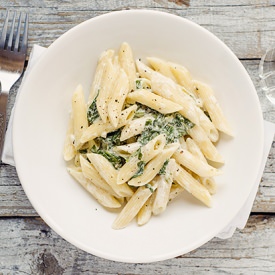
[108,69,129,127]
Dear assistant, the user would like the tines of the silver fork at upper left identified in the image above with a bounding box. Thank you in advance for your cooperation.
[0,11,29,53]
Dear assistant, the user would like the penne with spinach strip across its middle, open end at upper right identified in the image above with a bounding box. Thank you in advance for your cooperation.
[117,135,166,184]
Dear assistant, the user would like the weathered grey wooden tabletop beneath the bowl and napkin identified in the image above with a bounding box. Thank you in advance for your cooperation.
[0,0,275,275]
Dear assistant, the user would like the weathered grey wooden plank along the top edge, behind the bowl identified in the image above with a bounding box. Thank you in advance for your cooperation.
[0,0,275,58]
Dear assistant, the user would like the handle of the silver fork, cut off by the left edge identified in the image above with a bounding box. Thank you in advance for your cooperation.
[0,91,8,162]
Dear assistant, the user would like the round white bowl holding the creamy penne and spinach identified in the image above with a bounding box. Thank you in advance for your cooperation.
[13,10,263,262]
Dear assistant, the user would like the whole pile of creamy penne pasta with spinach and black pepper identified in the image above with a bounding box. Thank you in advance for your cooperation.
[63,42,232,229]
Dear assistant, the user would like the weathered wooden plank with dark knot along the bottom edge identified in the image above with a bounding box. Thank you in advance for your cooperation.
[0,215,275,275]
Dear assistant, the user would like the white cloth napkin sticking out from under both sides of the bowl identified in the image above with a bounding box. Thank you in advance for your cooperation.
[2,45,275,239]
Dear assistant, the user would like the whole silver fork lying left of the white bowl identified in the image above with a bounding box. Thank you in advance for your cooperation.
[0,11,29,160]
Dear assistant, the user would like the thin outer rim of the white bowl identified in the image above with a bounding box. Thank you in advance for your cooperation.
[13,9,264,263]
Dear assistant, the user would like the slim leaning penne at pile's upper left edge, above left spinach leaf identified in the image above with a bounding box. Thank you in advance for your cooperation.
[87,50,114,106]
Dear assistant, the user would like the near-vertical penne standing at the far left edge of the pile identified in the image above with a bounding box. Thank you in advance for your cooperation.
[72,85,88,150]
